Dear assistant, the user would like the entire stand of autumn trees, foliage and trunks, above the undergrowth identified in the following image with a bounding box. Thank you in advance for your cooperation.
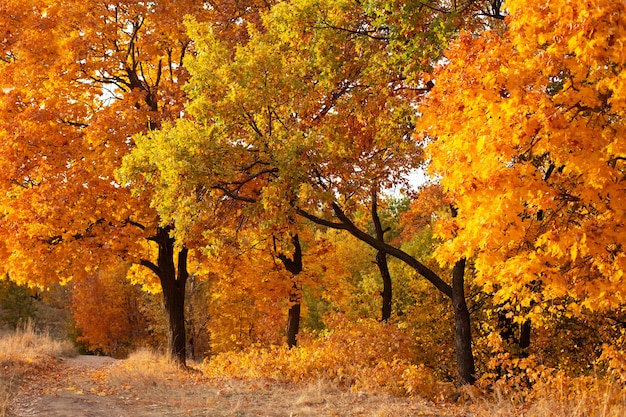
[0,0,626,383]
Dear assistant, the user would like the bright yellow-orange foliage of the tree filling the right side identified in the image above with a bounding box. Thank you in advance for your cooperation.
[420,0,626,364]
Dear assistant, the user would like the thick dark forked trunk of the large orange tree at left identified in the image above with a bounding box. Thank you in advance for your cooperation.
[141,227,189,367]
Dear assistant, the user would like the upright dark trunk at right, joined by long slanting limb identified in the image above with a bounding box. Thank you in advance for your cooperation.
[452,259,476,384]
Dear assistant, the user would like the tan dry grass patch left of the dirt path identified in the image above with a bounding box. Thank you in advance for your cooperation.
[0,322,76,417]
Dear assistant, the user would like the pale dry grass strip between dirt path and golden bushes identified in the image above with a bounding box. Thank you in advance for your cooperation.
[105,350,458,417]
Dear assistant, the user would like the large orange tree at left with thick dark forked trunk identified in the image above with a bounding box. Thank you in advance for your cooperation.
[0,0,267,364]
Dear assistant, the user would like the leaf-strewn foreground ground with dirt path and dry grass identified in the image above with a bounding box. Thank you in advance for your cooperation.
[7,356,464,417]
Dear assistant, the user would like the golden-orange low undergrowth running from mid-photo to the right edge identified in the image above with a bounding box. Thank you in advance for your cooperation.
[201,317,626,417]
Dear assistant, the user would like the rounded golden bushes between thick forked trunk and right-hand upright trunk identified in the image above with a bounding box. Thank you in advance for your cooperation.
[201,316,453,399]
